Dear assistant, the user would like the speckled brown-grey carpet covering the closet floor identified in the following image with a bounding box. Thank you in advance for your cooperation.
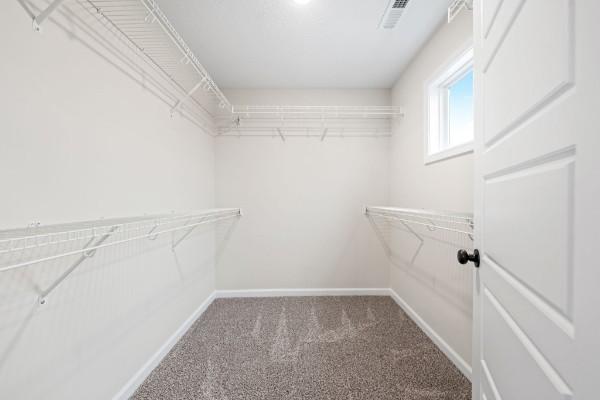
[133,296,471,400]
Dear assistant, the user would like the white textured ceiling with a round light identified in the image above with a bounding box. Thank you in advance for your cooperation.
[159,0,449,88]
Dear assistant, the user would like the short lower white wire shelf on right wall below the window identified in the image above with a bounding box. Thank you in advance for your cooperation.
[365,206,474,241]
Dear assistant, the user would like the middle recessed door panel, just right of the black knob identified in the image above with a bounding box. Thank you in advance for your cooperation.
[483,153,574,319]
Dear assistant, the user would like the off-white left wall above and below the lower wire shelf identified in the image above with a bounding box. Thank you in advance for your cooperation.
[0,0,215,399]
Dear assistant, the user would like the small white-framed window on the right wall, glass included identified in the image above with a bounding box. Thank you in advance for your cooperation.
[425,48,473,163]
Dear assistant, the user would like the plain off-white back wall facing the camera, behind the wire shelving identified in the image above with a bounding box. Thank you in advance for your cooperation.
[216,90,389,290]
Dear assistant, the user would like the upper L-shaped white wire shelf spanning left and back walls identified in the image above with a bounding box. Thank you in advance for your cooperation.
[33,0,403,140]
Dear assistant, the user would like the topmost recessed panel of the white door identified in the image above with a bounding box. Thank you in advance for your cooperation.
[482,0,573,145]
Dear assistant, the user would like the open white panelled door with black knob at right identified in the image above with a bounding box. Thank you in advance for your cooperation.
[473,0,600,400]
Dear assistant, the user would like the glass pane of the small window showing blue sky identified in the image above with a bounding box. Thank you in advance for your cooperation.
[448,70,473,146]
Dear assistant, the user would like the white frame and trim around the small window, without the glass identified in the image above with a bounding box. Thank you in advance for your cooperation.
[423,43,473,164]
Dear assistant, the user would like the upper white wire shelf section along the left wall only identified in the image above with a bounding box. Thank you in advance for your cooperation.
[33,0,231,129]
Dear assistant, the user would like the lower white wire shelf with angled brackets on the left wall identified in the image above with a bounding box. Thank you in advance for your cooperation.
[0,208,242,304]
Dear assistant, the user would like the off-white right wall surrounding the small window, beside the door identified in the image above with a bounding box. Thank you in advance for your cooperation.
[390,12,473,376]
